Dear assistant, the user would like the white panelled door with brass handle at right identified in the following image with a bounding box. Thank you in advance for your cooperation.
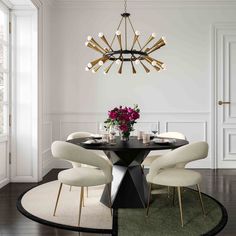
[214,24,236,168]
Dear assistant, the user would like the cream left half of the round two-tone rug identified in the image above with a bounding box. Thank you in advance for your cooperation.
[18,181,113,233]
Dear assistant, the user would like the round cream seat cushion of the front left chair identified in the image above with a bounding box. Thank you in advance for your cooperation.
[58,167,111,186]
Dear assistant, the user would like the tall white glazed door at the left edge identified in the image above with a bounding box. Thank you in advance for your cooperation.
[0,2,9,188]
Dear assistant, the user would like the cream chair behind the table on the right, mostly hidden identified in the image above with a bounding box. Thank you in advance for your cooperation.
[142,132,186,167]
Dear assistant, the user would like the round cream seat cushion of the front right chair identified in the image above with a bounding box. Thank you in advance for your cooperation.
[152,168,202,187]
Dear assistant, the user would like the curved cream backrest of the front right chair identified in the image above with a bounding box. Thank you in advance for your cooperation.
[149,142,209,181]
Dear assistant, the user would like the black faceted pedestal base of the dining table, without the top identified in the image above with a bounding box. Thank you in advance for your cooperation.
[101,150,149,208]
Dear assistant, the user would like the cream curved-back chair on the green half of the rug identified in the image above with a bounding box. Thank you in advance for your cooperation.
[146,142,208,227]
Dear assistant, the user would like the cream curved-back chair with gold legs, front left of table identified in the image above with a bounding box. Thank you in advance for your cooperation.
[51,141,112,226]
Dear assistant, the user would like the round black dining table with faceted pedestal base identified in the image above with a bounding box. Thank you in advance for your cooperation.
[68,136,188,208]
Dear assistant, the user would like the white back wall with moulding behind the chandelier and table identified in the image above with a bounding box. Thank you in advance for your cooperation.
[41,0,236,173]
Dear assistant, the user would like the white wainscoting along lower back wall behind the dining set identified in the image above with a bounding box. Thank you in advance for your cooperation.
[43,112,213,175]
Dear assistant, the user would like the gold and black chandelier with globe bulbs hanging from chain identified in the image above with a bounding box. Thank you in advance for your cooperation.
[85,0,166,74]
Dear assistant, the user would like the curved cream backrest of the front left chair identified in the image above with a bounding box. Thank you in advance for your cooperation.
[51,141,112,182]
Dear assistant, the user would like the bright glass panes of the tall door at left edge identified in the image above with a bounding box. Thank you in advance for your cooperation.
[0,2,9,135]
